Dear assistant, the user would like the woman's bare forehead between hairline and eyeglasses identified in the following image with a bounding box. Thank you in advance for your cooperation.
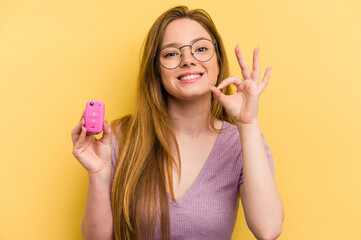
[162,19,211,46]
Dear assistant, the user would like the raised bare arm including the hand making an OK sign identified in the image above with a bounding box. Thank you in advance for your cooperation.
[211,46,283,239]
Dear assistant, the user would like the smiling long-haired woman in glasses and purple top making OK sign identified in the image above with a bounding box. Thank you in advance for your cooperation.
[72,6,283,240]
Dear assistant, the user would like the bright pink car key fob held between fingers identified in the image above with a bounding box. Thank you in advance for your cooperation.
[84,100,104,134]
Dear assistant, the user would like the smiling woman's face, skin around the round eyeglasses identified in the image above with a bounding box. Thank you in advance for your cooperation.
[159,19,219,100]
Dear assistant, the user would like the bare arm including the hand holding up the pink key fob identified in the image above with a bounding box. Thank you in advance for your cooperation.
[71,113,113,240]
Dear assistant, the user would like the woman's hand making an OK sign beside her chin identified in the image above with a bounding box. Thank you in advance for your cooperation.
[211,45,272,125]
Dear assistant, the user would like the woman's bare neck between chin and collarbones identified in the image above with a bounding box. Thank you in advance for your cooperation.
[168,94,212,137]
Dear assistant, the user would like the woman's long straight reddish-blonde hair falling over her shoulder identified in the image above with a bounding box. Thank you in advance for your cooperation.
[111,6,231,240]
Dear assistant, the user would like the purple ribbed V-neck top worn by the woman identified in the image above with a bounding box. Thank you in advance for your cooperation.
[110,121,274,240]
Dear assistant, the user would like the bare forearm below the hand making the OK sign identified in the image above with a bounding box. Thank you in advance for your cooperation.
[238,123,283,239]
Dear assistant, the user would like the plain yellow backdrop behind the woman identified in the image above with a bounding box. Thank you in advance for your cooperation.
[0,0,361,240]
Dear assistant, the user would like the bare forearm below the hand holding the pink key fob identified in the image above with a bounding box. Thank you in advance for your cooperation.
[81,170,113,240]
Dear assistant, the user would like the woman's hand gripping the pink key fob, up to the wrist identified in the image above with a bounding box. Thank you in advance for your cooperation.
[71,111,112,177]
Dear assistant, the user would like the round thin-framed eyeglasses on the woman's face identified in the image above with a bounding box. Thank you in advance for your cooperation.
[159,39,216,70]
